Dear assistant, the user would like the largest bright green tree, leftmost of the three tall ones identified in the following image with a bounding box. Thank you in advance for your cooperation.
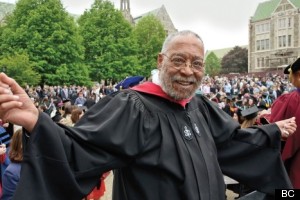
[0,0,90,85]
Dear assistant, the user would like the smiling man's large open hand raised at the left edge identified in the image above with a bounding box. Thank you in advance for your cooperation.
[0,73,39,132]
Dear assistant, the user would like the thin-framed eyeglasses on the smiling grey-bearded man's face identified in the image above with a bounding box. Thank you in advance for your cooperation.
[162,54,204,72]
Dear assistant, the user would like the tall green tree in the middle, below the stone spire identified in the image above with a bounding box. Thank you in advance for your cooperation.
[78,0,139,82]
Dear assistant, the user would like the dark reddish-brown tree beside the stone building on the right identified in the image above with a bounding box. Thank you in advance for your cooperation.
[221,46,248,73]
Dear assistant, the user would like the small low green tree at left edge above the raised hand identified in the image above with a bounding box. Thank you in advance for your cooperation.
[0,54,41,86]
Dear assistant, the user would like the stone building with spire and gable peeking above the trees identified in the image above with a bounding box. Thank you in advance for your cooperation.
[120,0,177,35]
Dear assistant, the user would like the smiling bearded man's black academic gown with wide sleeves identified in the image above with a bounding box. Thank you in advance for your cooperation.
[14,86,291,200]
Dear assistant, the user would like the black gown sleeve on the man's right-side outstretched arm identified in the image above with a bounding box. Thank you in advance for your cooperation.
[199,97,292,195]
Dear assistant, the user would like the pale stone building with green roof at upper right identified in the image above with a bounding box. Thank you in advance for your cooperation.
[248,0,300,72]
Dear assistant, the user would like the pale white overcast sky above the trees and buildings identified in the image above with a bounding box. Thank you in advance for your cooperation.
[5,0,268,50]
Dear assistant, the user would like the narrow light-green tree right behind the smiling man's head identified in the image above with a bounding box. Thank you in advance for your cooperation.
[134,15,166,77]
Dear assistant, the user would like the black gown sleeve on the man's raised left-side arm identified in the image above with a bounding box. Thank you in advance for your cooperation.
[14,93,150,200]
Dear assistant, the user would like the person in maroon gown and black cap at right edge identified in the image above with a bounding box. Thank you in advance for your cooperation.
[270,58,300,189]
